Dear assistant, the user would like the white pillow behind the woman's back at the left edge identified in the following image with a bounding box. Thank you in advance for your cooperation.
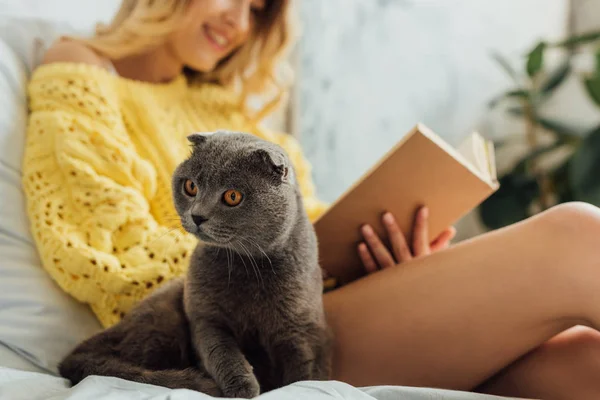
[0,18,100,374]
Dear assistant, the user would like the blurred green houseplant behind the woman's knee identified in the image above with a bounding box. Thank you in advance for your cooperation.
[479,32,600,229]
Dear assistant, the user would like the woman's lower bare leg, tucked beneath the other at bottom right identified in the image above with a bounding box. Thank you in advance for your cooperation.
[477,327,600,400]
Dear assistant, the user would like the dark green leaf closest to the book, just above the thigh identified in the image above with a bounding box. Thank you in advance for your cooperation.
[478,172,539,229]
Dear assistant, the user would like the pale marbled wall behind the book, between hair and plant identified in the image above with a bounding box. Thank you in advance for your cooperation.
[298,0,568,206]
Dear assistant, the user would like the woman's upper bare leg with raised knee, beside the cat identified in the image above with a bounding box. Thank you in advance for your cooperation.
[325,203,600,390]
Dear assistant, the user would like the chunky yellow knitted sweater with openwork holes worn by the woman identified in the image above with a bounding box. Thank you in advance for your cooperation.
[23,63,324,326]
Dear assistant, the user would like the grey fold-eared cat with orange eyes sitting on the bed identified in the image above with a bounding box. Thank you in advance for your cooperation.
[59,131,331,398]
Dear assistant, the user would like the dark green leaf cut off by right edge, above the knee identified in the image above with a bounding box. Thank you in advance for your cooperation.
[568,127,600,206]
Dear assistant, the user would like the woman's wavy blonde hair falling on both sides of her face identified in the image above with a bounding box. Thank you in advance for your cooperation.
[79,0,295,119]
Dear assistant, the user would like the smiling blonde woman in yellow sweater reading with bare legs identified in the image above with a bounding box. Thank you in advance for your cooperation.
[23,0,600,399]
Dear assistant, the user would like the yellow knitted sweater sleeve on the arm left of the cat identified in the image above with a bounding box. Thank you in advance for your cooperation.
[23,68,196,326]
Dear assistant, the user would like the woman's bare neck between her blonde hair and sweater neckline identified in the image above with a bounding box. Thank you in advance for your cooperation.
[113,45,183,83]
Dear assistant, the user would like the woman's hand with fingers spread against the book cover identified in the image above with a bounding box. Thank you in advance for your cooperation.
[358,207,456,273]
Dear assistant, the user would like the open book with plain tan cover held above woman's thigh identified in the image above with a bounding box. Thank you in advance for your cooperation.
[314,124,499,284]
